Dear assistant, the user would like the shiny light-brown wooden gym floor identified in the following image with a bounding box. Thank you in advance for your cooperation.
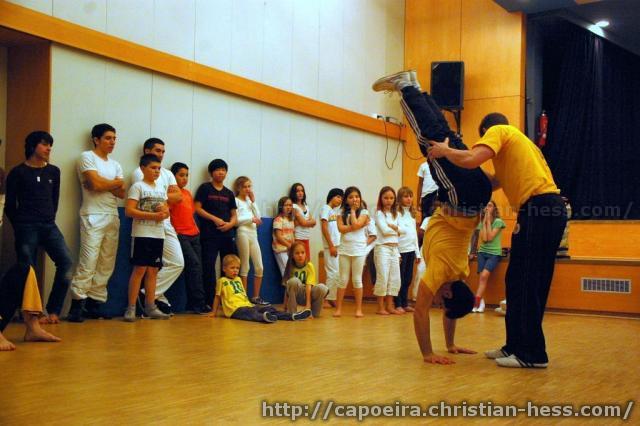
[0,304,640,425]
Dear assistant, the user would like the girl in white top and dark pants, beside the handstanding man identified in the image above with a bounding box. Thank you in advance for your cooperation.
[395,186,422,312]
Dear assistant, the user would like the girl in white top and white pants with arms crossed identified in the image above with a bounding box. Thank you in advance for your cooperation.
[373,186,404,315]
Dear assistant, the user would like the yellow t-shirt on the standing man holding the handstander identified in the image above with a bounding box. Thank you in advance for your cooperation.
[474,125,560,211]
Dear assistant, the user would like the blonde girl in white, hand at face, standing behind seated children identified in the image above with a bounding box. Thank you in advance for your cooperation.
[233,176,265,305]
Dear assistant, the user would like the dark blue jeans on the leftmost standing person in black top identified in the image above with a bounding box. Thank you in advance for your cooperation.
[13,222,73,315]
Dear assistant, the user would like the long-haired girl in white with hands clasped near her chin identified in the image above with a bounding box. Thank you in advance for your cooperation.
[333,186,369,318]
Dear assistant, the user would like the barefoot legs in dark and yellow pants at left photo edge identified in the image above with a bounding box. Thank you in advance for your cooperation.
[0,263,60,352]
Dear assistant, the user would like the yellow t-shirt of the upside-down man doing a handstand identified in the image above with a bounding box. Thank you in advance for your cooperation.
[421,207,478,295]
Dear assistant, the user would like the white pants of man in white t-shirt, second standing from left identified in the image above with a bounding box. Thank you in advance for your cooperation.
[71,214,120,302]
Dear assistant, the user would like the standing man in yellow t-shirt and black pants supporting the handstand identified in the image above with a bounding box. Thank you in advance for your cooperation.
[428,113,567,368]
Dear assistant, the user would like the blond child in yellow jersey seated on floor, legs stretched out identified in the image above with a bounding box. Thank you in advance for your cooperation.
[211,254,311,323]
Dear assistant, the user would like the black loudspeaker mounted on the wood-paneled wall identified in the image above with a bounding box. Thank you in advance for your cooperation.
[431,62,464,110]
